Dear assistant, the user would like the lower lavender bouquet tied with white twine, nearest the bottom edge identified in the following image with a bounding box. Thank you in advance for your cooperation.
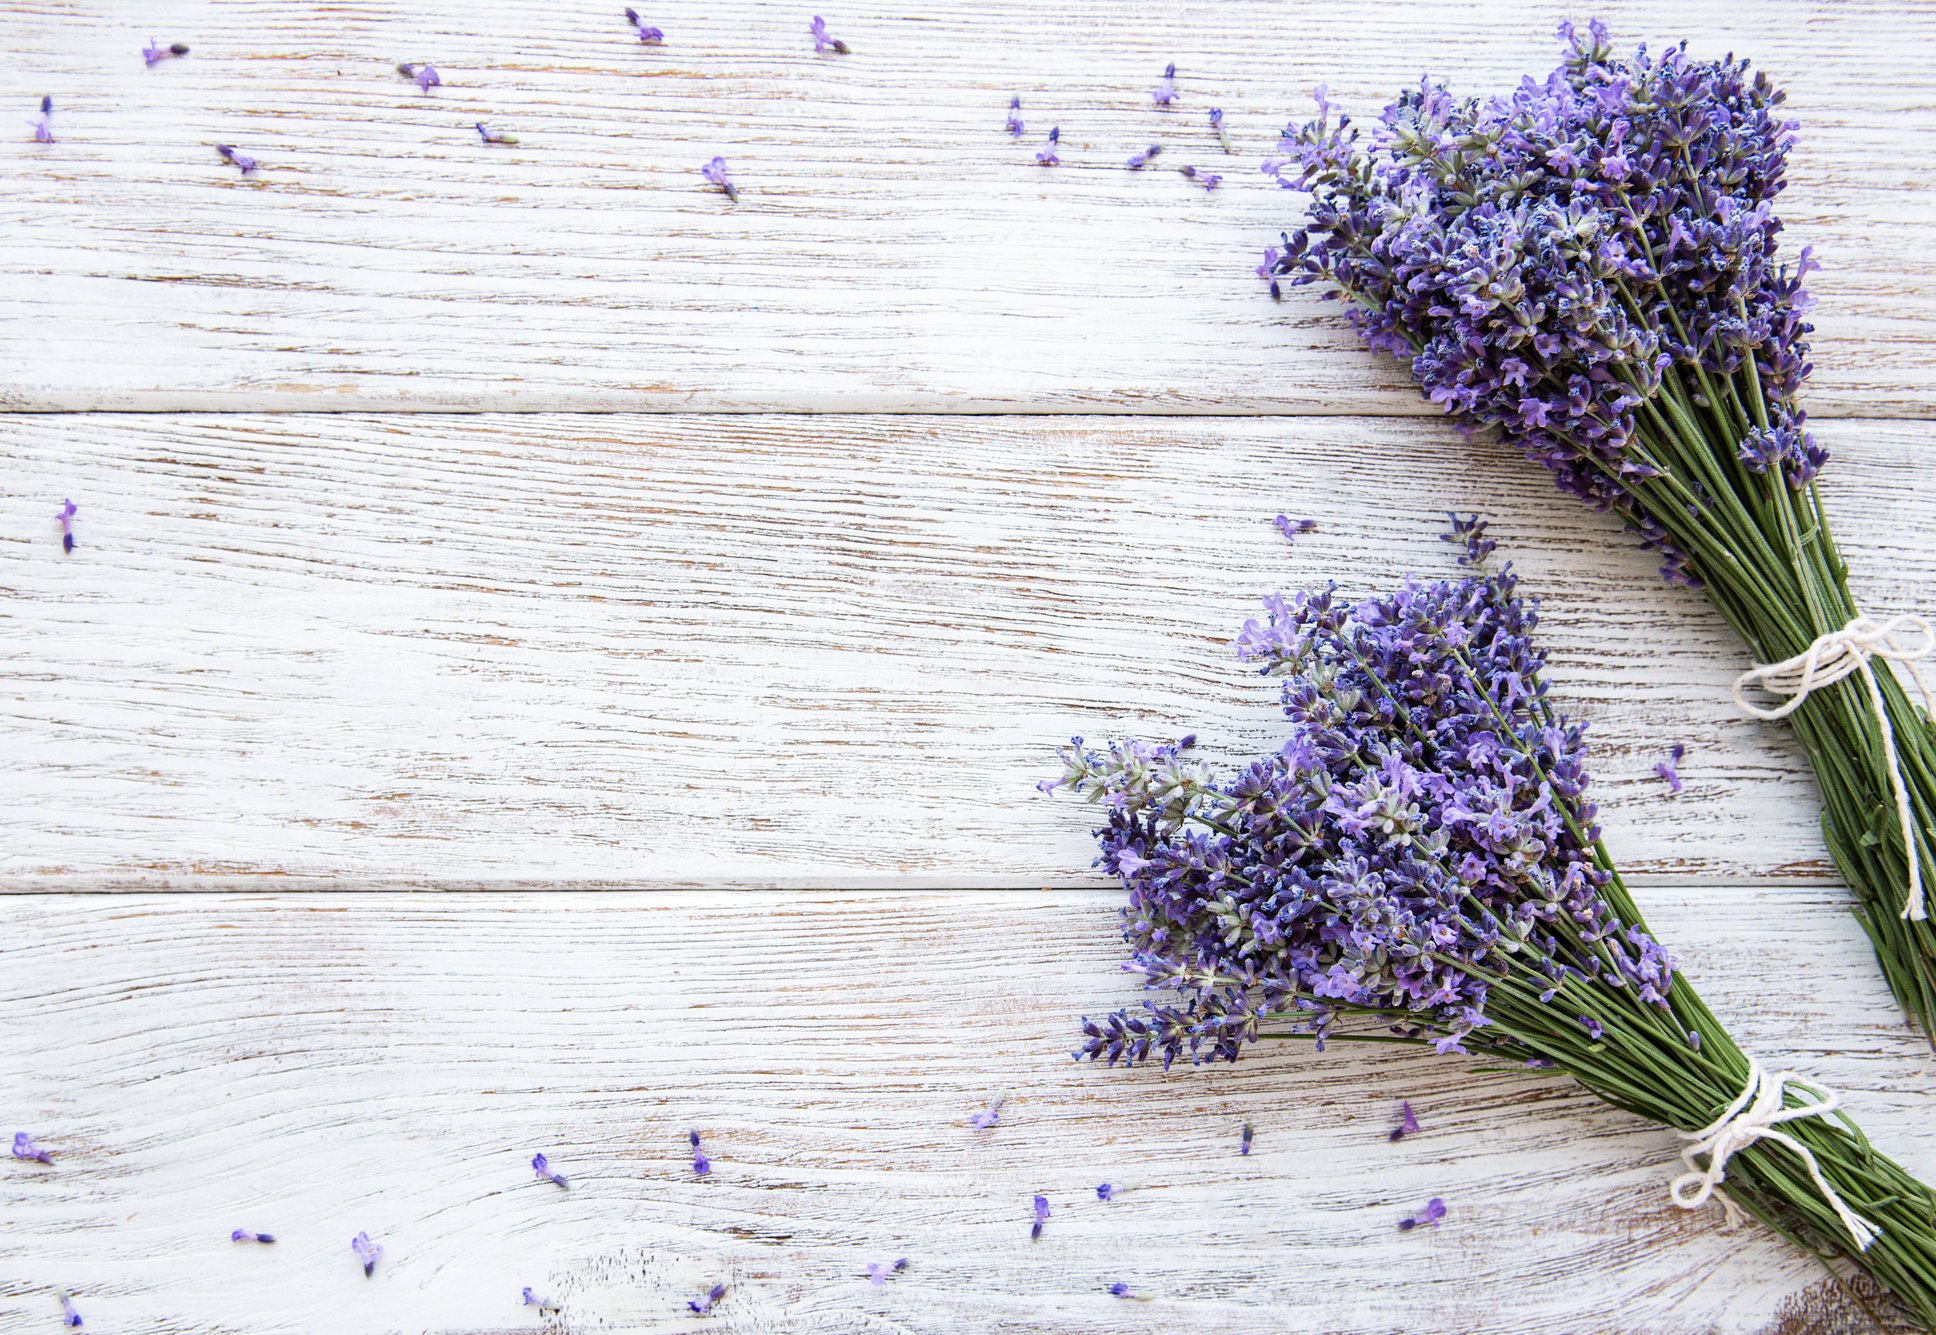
[1044,571,1936,1329]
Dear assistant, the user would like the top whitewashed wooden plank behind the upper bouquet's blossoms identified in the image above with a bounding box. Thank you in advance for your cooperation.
[0,0,1936,416]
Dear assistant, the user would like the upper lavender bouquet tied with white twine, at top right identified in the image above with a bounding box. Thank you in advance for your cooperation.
[1264,21,1936,1037]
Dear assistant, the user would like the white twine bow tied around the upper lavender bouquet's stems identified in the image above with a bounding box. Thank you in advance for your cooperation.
[1735,615,1936,923]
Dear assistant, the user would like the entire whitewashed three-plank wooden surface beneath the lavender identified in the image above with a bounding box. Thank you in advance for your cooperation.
[0,0,1936,1335]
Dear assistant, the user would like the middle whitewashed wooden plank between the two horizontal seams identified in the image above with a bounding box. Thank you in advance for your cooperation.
[0,416,1936,888]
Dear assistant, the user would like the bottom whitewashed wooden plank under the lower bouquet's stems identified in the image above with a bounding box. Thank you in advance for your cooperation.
[0,888,1936,1335]
